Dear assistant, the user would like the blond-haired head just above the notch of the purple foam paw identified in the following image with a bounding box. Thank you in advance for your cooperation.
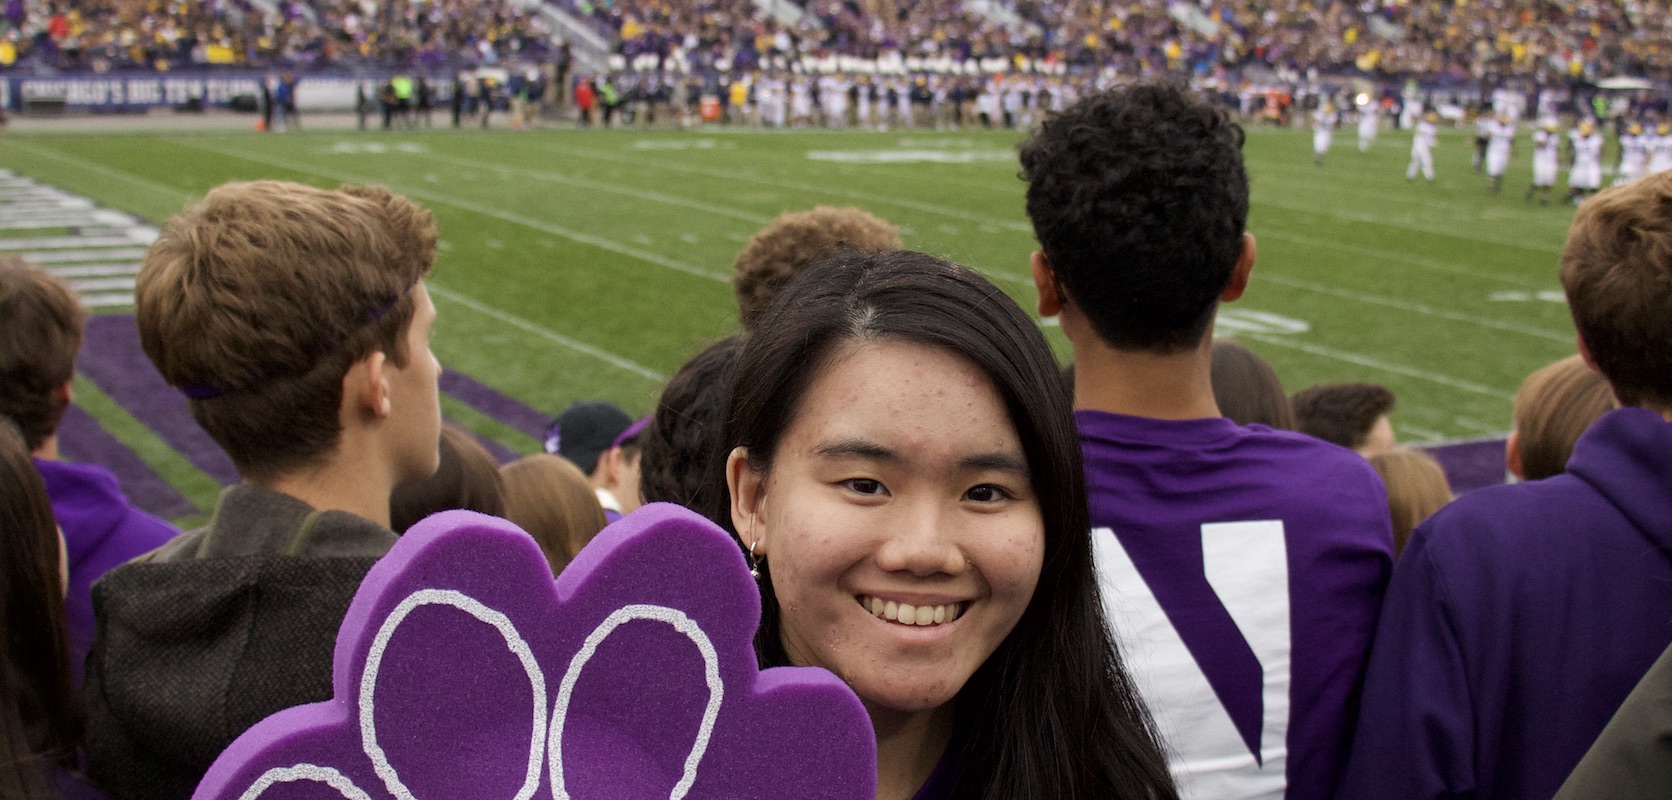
[500,454,609,576]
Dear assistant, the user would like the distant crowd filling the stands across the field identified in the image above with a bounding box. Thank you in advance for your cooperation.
[0,0,1672,84]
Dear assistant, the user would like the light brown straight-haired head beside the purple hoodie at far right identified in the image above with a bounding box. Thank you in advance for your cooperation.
[1505,355,1615,480]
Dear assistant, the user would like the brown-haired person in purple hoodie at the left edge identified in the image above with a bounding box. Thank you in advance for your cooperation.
[0,256,179,679]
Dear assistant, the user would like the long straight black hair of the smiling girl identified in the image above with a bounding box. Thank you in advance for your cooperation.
[702,251,1177,798]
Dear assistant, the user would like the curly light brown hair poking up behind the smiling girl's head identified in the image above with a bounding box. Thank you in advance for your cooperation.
[732,206,900,331]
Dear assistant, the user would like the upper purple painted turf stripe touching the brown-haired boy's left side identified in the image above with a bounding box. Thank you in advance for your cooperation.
[75,315,237,484]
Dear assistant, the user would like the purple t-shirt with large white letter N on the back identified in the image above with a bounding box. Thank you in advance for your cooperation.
[1075,410,1393,800]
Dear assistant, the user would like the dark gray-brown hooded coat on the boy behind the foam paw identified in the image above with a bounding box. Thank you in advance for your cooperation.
[82,485,395,798]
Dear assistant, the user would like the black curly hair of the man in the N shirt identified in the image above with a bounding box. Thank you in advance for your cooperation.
[1022,82,1249,353]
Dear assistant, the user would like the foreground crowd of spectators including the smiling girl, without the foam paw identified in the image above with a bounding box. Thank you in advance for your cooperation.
[0,82,1672,800]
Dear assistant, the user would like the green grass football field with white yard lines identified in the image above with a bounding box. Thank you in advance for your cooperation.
[0,120,1573,525]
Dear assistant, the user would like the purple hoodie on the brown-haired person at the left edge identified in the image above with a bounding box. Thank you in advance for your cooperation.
[35,459,179,683]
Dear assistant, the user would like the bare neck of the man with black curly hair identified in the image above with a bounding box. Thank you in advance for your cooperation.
[1073,340,1221,420]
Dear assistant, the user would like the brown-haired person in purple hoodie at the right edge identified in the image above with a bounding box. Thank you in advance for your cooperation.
[1341,172,1672,800]
